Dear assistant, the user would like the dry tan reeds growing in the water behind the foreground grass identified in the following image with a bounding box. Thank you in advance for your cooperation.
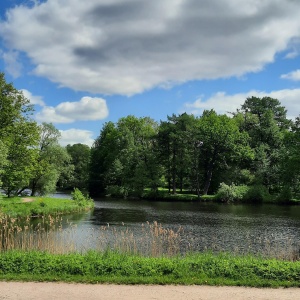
[0,216,300,261]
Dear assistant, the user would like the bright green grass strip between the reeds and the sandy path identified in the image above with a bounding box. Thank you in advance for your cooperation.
[0,251,300,287]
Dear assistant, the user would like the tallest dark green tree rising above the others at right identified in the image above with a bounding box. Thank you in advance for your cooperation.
[235,97,292,192]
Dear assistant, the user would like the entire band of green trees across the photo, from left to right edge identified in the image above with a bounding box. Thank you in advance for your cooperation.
[0,73,300,199]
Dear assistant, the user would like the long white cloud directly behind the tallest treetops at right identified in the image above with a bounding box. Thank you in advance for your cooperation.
[183,89,300,119]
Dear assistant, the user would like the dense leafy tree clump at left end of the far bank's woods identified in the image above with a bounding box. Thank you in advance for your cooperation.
[90,116,161,196]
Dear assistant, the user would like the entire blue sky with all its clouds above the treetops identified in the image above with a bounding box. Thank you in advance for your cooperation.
[0,0,300,146]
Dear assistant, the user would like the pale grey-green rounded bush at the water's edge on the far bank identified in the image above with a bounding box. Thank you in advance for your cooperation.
[216,182,249,202]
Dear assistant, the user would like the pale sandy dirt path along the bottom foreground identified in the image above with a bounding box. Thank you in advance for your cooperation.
[0,282,300,300]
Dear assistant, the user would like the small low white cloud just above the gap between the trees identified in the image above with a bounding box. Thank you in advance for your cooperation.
[59,128,94,147]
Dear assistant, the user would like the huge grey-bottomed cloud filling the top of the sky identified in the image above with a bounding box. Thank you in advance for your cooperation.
[0,0,300,95]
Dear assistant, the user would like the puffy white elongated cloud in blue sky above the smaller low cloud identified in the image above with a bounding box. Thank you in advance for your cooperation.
[36,97,108,123]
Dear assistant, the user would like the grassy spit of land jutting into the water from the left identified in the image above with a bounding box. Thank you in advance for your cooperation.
[0,197,93,218]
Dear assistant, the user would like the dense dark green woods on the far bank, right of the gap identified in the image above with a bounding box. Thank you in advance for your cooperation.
[89,97,300,200]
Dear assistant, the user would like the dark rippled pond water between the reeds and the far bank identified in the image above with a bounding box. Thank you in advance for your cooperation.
[54,199,300,255]
